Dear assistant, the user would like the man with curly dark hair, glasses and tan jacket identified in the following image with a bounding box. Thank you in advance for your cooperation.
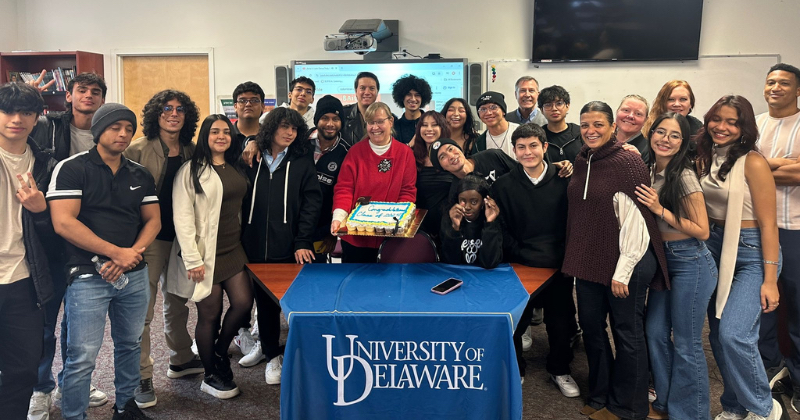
[124,89,203,408]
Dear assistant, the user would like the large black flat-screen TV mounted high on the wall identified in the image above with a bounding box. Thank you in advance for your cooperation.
[531,0,703,63]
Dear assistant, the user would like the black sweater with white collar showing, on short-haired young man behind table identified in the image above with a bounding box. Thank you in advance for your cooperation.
[492,164,569,268]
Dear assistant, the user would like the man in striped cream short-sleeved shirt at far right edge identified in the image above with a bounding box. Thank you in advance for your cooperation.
[756,63,800,411]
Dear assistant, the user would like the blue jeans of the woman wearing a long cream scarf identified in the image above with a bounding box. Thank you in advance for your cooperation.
[706,224,780,417]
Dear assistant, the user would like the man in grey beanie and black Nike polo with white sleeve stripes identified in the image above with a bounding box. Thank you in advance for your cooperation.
[47,104,161,419]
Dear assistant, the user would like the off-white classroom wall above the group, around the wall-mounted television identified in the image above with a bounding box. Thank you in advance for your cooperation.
[7,0,800,110]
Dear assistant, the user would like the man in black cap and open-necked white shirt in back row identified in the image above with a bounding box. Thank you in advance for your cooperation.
[475,91,519,159]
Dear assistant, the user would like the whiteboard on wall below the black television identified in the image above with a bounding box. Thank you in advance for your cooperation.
[485,54,780,123]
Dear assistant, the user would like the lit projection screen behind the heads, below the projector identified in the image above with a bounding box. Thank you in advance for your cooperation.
[292,59,467,116]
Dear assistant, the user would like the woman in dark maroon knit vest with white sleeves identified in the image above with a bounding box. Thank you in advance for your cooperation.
[562,101,669,419]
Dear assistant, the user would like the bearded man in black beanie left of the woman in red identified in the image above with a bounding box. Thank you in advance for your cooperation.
[308,95,349,263]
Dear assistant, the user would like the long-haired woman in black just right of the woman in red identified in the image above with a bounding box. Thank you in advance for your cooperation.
[411,111,456,241]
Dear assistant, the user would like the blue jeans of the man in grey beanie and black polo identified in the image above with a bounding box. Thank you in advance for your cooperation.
[61,267,150,420]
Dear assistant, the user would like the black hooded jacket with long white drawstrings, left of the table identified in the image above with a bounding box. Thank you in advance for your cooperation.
[242,150,322,263]
